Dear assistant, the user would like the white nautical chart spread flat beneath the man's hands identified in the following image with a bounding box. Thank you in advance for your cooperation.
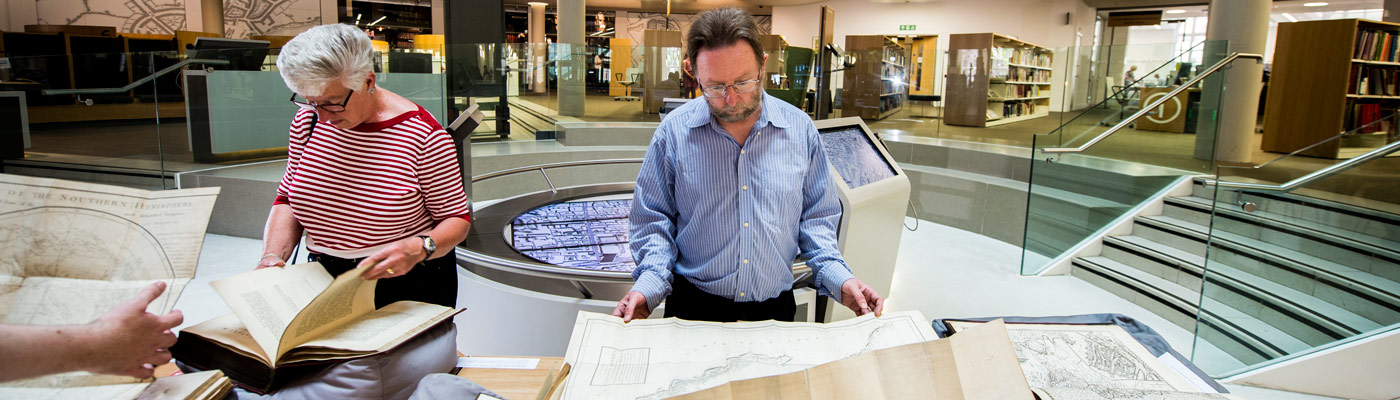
[564,312,938,399]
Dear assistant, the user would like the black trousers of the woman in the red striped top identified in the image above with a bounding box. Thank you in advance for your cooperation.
[309,249,456,308]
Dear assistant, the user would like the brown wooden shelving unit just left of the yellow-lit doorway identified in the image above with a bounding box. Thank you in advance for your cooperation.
[841,35,910,119]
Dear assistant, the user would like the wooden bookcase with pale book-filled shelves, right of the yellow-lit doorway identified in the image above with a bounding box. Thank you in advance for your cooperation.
[944,34,1054,127]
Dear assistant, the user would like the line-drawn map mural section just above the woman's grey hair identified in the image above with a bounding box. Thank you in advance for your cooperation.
[224,0,321,39]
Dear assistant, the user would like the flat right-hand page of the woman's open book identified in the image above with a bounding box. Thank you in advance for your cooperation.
[302,301,454,351]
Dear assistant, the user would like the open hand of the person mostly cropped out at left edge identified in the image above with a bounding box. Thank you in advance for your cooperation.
[80,283,185,379]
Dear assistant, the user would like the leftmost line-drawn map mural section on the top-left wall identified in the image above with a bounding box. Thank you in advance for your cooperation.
[35,0,187,35]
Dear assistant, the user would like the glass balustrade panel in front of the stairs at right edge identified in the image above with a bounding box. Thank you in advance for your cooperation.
[1192,115,1400,376]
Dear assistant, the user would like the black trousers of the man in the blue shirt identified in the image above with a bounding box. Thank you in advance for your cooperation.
[665,276,797,322]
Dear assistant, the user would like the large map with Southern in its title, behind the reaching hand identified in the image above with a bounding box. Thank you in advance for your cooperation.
[0,173,218,399]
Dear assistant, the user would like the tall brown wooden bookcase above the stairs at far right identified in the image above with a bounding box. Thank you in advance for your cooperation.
[1261,20,1400,158]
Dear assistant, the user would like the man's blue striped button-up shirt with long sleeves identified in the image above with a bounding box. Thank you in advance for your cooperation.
[630,94,853,309]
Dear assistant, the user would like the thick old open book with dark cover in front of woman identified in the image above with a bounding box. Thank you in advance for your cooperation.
[171,263,458,393]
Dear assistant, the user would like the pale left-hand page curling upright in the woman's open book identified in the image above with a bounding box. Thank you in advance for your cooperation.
[210,263,332,365]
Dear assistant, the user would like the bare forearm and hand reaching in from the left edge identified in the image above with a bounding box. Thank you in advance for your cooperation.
[0,283,185,382]
